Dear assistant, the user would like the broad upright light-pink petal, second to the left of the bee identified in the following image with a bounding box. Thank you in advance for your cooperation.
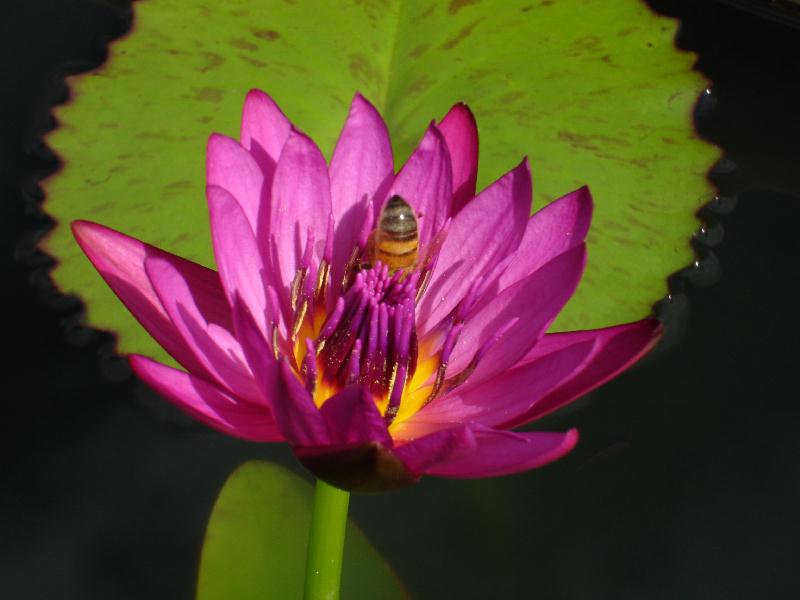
[270,130,331,298]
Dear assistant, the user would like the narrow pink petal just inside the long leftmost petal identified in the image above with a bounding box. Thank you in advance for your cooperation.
[145,257,264,404]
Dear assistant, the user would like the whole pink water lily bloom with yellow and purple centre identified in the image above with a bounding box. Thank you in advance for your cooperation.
[73,91,660,491]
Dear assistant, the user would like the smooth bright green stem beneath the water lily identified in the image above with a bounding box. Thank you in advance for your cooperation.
[303,479,350,600]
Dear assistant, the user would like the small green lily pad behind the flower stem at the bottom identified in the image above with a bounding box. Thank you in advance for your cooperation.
[197,461,408,600]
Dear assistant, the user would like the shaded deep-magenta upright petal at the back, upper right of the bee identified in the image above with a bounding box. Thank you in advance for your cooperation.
[439,103,478,215]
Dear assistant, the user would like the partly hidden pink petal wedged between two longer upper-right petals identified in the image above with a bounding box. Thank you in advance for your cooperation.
[498,186,592,290]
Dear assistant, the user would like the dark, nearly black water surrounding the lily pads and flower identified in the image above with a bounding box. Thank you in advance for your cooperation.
[0,0,800,600]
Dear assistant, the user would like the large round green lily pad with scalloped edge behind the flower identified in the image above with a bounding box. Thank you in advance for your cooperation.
[44,0,718,366]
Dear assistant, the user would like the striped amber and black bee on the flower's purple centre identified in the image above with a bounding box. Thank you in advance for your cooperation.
[367,196,419,274]
